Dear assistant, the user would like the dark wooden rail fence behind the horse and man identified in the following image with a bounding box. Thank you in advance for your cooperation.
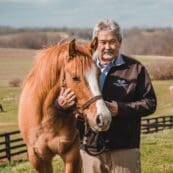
[0,115,173,161]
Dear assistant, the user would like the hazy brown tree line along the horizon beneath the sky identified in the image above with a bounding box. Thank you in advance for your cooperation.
[0,26,173,56]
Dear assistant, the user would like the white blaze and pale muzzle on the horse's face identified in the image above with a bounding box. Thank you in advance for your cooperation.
[85,65,112,131]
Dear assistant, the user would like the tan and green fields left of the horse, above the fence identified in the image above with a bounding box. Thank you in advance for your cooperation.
[0,48,37,133]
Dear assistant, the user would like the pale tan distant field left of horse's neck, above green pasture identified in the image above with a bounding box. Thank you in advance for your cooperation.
[0,48,36,86]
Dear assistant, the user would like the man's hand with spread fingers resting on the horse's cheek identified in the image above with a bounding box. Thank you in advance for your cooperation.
[57,87,76,110]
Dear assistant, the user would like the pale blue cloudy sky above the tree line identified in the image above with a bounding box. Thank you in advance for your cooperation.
[0,0,173,28]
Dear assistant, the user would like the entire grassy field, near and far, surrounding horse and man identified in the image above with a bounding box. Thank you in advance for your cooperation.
[0,48,173,173]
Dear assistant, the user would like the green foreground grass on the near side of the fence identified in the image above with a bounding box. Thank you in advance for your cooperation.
[0,130,173,173]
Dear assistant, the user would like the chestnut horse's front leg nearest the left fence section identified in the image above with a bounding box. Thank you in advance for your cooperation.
[28,147,53,173]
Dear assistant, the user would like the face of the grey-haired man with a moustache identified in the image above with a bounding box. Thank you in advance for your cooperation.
[97,31,121,65]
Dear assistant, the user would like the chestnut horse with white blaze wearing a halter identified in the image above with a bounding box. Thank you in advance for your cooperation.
[18,38,111,173]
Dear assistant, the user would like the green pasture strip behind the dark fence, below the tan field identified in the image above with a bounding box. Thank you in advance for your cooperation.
[0,80,173,133]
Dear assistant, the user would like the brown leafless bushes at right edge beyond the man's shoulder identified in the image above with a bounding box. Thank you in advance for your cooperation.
[147,59,173,80]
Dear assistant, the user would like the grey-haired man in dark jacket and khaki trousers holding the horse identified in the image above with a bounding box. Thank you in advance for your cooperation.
[55,20,156,173]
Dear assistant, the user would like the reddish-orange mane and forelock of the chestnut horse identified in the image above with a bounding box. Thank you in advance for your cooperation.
[24,41,91,98]
